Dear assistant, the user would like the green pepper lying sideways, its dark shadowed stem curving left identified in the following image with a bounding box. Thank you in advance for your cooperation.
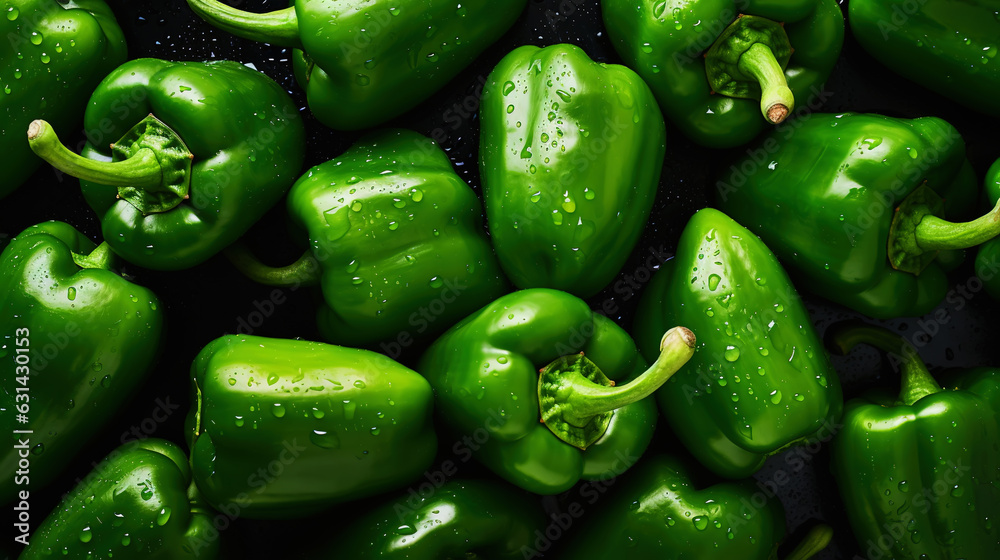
[229,130,507,353]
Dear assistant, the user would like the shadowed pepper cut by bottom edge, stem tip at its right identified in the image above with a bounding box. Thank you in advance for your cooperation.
[560,455,833,560]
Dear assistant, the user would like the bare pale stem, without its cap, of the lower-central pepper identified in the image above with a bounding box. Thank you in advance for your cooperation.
[564,327,695,425]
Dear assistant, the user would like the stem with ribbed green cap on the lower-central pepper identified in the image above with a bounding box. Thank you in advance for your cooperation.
[538,327,695,449]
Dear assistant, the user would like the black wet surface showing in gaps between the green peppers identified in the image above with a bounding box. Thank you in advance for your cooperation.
[0,0,1000,559]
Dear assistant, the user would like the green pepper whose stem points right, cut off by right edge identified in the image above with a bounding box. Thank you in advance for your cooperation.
[719,113,1000,319]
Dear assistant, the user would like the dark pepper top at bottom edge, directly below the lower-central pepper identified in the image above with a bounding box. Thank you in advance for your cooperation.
[320,480,547,560]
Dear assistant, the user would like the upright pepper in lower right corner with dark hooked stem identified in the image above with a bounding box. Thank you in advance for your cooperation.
[827,324,1000,560]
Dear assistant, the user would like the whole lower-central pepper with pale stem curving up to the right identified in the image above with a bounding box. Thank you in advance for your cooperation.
[418,288,694,494]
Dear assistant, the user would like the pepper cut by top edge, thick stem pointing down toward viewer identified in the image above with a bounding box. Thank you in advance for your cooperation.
[601,0,844,148]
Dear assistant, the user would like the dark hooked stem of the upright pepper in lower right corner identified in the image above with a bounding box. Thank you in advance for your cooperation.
[827,321,942,405]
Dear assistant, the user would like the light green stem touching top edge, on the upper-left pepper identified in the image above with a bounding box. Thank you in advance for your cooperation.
[188,0,302,49]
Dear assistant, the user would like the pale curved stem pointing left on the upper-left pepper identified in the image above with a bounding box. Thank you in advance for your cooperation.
[28,120,163,188]
